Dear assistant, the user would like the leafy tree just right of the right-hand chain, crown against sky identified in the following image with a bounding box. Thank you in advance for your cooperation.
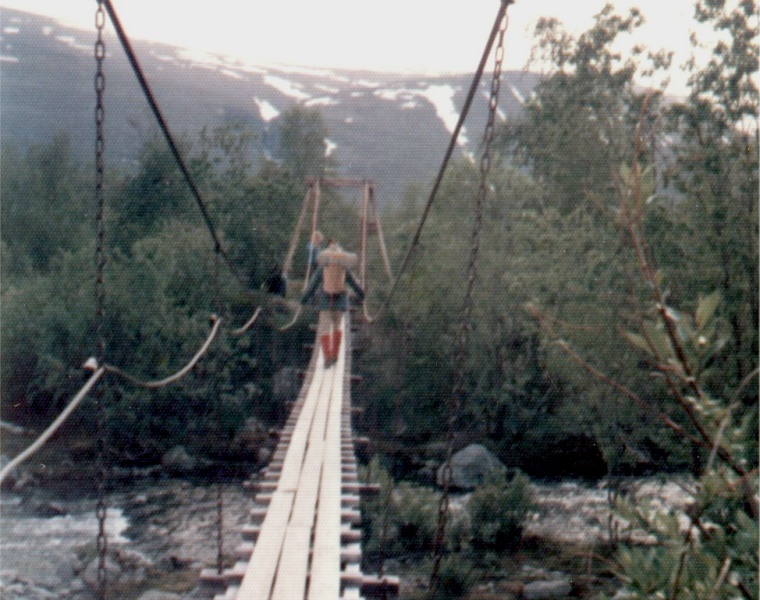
[501,4,668,212]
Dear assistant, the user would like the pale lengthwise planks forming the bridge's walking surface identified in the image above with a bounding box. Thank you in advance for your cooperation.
[236,317,361,600]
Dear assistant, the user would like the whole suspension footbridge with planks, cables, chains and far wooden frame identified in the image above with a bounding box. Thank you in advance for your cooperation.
[0,0,512,600]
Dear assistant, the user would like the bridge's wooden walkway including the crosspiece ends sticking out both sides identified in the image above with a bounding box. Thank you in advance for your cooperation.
[202,316,398,600]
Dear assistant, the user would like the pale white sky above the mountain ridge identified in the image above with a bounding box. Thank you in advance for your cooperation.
[0,0,728,93]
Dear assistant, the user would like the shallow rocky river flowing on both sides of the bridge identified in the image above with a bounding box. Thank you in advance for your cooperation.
[0,477,689,600]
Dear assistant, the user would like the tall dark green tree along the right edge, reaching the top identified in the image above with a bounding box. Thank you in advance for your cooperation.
[655,0,760,402]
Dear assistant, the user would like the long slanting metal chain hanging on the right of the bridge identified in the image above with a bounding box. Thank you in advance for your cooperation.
[430,7,509,596]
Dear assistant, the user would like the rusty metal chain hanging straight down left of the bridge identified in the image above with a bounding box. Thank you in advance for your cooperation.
[95,0,108,600]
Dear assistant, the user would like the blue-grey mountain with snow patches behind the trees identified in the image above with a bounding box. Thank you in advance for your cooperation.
[0,9,537,203]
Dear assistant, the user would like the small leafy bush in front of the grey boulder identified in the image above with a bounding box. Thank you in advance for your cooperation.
[468,473,533,550]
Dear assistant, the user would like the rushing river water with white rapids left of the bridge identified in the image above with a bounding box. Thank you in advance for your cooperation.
[0,479,250,600]
